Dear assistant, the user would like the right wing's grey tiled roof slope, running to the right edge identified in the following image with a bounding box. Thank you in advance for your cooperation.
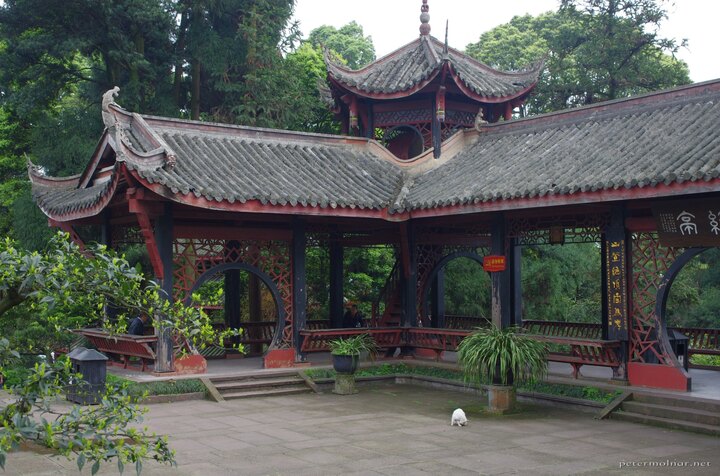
[403,84,720,209]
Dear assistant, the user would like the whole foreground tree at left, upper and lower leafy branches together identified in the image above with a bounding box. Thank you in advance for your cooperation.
[0,233,245,474]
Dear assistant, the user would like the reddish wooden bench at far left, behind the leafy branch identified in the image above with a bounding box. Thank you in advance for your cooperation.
[75,329,157,372]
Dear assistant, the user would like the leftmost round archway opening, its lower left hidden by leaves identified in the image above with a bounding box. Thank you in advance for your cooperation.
[185,263,285,354]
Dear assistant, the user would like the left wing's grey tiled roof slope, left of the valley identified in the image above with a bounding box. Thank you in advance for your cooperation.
[127,118,402,209]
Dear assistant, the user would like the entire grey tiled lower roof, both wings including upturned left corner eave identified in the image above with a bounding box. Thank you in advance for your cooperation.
[30,80,720,219]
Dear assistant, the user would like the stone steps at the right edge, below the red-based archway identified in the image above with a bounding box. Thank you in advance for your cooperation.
[610,393,720,436]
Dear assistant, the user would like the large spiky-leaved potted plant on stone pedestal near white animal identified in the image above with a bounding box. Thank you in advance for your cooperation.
[458,325,547,413]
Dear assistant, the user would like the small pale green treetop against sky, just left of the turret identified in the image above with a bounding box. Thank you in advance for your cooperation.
[307,21,375,69]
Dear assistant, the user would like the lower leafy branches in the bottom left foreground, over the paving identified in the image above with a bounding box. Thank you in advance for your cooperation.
[0,338,175,474]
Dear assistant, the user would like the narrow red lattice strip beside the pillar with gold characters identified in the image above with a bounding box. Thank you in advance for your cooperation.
[630,233,679,365]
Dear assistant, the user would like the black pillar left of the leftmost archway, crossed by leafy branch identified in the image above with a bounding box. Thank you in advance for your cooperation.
[155,203,175,372]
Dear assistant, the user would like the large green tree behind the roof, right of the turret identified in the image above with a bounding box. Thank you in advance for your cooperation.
[467,0,690,113]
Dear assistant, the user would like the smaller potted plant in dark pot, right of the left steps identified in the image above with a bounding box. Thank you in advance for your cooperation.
[328,334,378,395]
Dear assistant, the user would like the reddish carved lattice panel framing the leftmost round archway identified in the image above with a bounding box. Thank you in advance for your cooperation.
[173,239,293,348]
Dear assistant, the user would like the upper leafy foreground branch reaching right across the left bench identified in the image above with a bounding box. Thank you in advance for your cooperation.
[0,233,242,356]
